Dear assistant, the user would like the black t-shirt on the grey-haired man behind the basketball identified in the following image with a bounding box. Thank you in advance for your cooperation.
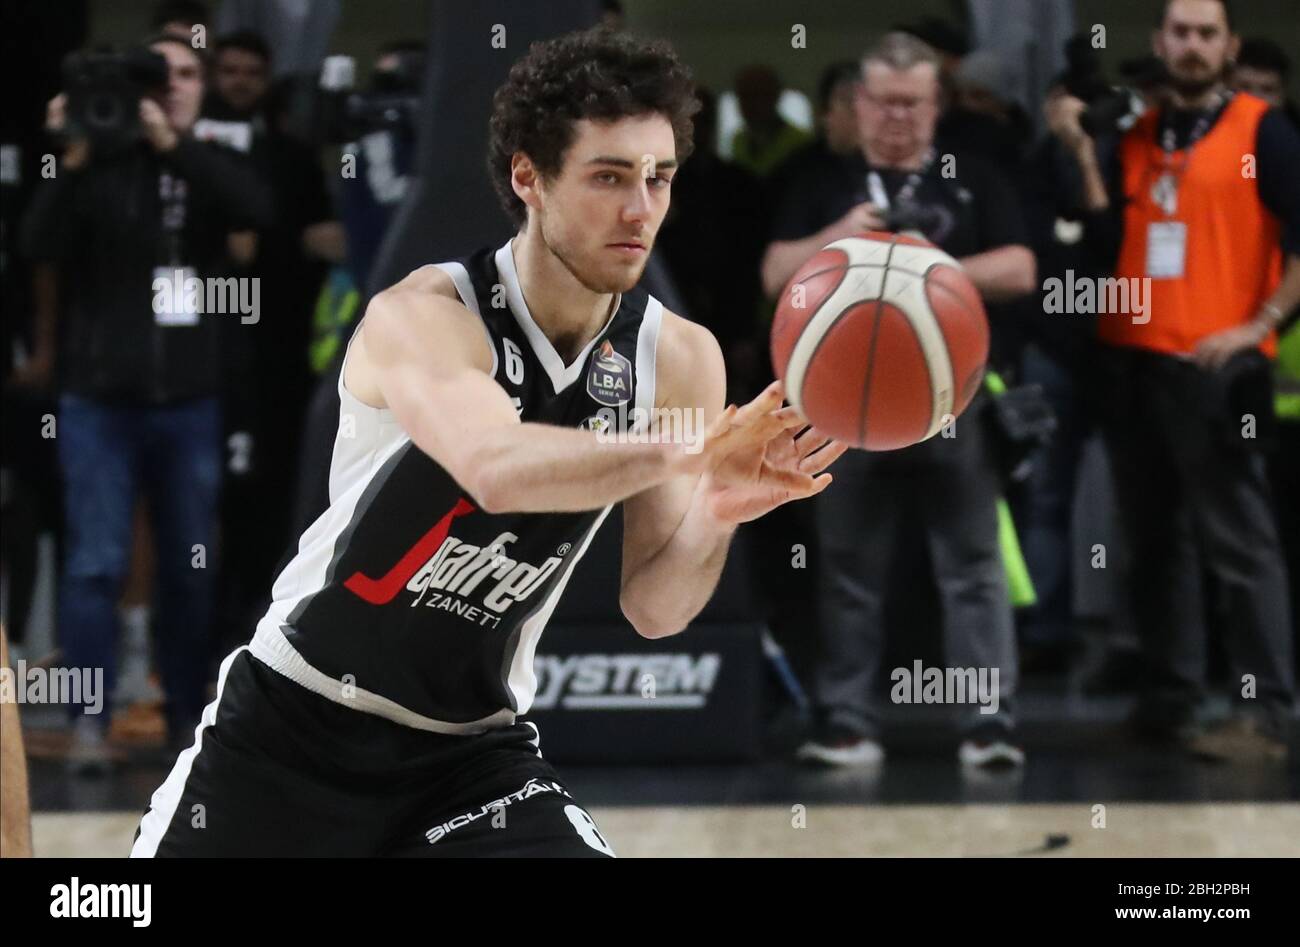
[771,145,1030,258]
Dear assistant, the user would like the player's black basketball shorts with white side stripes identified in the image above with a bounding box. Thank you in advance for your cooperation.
[131,648,614,857]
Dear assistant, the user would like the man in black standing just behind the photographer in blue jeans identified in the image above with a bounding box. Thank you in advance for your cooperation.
[195,30,346,649]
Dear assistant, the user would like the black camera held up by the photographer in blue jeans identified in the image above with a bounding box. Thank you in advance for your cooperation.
[64,48,168,153]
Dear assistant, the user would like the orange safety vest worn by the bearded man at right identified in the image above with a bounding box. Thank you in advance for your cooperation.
[1099,92,1282,356]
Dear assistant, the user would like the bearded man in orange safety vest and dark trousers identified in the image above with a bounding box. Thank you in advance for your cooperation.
[1047,0,1300,760]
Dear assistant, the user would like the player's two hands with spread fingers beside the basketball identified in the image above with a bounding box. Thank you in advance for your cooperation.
[701,381,848,523]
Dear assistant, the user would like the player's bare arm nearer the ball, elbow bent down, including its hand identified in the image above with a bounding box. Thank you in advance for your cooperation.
[620,312,846,637]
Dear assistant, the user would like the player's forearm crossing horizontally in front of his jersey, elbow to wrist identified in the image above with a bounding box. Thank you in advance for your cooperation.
[471,421,689,513]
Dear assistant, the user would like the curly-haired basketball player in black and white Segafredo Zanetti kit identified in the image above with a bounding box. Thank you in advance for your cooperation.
[133,31,844,856]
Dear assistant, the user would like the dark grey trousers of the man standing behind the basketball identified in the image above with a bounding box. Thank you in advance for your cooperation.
[814,401,1018,738]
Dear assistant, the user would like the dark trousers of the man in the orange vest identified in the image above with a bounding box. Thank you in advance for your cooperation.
[1096,349,1295,728]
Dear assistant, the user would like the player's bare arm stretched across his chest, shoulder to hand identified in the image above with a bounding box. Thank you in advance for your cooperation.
[345,267,787,513]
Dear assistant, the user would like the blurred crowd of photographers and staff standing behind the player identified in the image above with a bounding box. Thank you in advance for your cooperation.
[3,0,1300,766]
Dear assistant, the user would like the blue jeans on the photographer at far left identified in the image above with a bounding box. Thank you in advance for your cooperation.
[56,394,221,738]
